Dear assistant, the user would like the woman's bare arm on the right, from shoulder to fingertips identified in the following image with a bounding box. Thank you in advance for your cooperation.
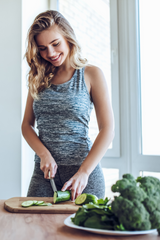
[62,66,114,200]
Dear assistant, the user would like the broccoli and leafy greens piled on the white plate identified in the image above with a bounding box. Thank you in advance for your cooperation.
[72,174,160,235]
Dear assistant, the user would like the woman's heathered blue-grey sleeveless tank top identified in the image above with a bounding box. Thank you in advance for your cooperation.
[33,68,93,165]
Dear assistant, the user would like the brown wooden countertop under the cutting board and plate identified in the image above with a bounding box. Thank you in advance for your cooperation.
[0,200,160,240]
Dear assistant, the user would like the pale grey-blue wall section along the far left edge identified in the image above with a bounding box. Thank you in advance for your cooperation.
[0,0,22,199]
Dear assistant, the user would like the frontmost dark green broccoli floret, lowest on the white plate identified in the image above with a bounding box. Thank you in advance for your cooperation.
[111,196,151,230]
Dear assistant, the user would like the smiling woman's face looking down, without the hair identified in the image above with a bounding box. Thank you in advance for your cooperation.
[36,24,70,67]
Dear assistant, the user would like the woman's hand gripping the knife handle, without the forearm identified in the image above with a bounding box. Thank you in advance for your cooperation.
[40,153,57,179]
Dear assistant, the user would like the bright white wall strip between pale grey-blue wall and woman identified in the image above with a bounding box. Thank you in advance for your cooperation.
[21,0,48,197]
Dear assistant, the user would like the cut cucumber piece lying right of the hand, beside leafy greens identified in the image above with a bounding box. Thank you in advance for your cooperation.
[75,193,98,205]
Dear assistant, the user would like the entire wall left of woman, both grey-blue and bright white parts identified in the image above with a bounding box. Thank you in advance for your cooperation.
[0,0,49,199]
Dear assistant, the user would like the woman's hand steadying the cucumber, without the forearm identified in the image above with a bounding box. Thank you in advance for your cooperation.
[62,172,88,201]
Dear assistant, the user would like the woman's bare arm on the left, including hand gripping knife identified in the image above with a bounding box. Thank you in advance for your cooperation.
[21,92,57,178]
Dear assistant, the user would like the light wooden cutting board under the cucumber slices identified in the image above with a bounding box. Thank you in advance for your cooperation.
[4,197,79,213]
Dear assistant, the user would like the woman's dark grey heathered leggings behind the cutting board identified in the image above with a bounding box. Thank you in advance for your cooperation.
[27,162,105,198]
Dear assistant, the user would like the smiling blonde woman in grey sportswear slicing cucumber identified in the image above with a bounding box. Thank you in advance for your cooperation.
[22,11,114,200]
